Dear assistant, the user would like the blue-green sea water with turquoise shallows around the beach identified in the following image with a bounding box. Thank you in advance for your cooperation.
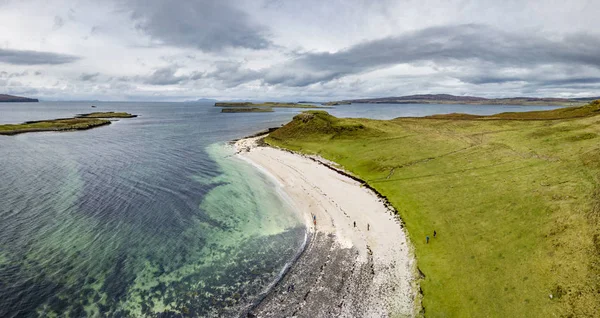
[0,102,557,317]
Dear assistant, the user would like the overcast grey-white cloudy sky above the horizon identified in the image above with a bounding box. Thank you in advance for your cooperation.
[0,0,600,101]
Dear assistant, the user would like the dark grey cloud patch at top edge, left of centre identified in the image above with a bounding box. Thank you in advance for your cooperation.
[127,0,271,51]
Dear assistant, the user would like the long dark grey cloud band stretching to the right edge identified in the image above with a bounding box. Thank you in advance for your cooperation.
[264,24,600,86]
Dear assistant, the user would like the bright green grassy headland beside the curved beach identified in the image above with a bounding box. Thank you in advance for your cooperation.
[266,101,600,317]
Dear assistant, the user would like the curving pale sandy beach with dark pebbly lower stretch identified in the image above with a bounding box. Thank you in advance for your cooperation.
[235,136,417,317]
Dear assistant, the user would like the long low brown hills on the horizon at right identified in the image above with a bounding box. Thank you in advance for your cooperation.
[323,94,600,106]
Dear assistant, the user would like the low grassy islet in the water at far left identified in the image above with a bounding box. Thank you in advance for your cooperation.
[0,112,137,135]
